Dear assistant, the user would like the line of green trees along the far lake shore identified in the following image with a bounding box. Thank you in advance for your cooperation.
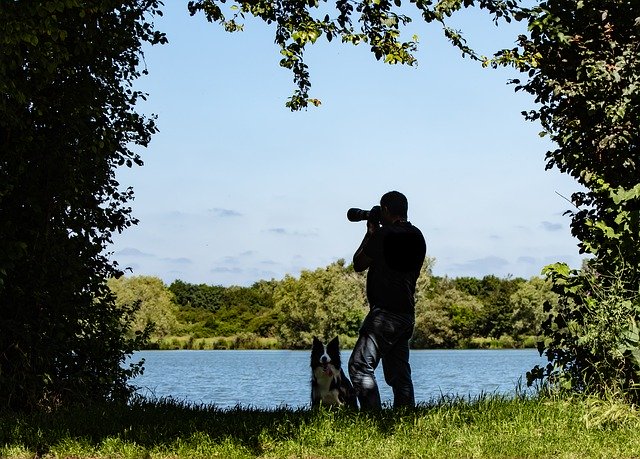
[108,259,557,349]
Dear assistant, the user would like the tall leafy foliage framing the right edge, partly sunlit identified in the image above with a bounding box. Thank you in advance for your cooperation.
[494,0,640,392]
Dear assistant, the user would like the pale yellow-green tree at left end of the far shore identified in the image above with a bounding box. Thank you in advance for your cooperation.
[107,276,178,337]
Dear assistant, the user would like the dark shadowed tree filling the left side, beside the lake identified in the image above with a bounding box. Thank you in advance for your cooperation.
[0,0,165,409]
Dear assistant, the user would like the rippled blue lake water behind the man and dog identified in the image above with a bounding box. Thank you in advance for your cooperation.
[132,349,543,408]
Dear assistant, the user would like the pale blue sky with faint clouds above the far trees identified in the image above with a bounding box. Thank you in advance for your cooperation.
[109,1,580,286]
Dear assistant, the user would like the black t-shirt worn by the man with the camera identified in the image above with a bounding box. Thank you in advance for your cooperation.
[364,222,426,314]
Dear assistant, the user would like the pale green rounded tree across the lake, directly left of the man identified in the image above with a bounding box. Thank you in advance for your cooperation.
[274,260,368,349]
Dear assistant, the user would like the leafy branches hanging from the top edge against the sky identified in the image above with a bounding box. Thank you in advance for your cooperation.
[188,0,520,110]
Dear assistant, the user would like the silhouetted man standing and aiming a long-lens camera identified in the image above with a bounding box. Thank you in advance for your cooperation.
[348,191,426,410]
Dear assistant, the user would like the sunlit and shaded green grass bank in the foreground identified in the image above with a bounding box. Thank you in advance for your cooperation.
[0,396,640,459]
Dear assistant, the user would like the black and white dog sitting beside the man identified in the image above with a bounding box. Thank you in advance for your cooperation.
[311,336,358,409]
